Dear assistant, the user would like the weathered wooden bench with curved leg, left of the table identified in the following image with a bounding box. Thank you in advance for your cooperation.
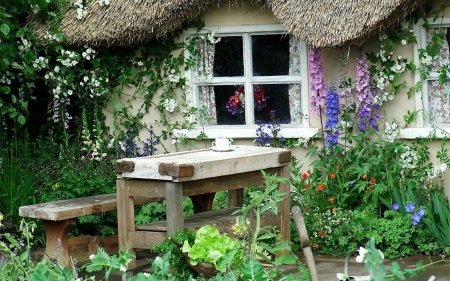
[19,193,163,266]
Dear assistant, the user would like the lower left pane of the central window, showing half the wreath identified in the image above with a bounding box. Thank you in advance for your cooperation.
[214,85,245,125]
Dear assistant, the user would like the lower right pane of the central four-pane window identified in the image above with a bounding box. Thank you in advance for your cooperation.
[253,84,300,124]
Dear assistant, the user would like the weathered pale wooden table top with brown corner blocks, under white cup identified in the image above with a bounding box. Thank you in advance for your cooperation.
[116,145,291,182]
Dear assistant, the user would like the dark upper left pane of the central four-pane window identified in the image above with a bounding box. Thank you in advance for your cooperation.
[213,36,244,77]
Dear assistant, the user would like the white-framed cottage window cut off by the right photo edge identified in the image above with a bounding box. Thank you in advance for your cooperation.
[402,18,450,138]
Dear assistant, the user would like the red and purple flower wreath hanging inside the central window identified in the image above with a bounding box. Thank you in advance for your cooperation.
[225,85,270,115]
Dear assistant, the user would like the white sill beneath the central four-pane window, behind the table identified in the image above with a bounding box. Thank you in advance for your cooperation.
[174,126,319,139]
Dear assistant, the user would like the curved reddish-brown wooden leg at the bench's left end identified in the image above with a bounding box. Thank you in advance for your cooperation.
[43,219,74,268]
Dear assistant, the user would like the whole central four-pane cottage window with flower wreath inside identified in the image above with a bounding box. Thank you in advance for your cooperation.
[176,25,316,138]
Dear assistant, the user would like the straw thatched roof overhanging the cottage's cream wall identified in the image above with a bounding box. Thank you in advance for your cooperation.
[31,0,426,47]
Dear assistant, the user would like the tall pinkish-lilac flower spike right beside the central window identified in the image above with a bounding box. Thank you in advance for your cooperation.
[308,48,326,114]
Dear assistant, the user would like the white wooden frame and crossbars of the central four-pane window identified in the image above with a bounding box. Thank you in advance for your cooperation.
[174,24,318,139]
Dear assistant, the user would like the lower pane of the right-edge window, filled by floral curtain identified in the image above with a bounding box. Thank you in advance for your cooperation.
[428,80,450,124]
